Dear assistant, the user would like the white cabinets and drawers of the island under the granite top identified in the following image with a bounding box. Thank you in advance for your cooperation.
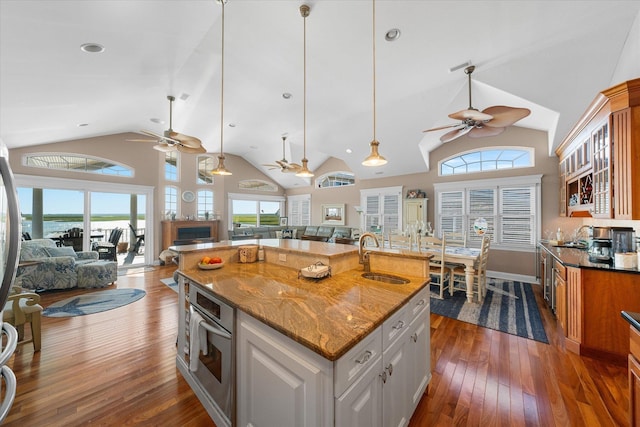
[237,288,431,427]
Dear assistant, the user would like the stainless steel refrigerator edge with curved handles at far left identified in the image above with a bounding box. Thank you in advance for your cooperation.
[0,141,22,424]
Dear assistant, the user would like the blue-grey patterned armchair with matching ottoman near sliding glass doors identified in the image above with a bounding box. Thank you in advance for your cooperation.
[16,239,118,291]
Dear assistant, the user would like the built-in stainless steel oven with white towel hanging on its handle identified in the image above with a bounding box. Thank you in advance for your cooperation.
[188,284,236,425]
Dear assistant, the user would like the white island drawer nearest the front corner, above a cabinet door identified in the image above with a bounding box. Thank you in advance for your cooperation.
[333,327,382,397]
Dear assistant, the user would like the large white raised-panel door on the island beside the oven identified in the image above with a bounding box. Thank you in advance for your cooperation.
[236,312,333,427]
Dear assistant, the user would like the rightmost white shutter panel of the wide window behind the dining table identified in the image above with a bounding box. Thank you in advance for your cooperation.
[500,187,535,245]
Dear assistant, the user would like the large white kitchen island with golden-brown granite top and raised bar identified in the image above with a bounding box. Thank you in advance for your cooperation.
[172,239,431,426]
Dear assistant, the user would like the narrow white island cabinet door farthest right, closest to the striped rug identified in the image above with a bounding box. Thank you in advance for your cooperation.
[407,310,431,414]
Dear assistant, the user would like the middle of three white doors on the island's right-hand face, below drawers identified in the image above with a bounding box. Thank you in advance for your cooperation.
[382,330,411,427]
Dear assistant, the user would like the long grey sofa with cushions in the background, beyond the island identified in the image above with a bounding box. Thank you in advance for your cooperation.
[229,225,360,243]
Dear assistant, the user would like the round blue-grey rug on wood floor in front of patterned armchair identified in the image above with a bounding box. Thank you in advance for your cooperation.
[42,288,146,317]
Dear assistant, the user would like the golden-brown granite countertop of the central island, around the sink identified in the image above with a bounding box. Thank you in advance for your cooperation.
[180,260,428,361]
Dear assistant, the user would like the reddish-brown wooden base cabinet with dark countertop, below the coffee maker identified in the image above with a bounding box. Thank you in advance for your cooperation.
[538,242,640,365]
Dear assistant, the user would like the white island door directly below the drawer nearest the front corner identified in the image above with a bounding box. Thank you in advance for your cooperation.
[335,356,383,427]
